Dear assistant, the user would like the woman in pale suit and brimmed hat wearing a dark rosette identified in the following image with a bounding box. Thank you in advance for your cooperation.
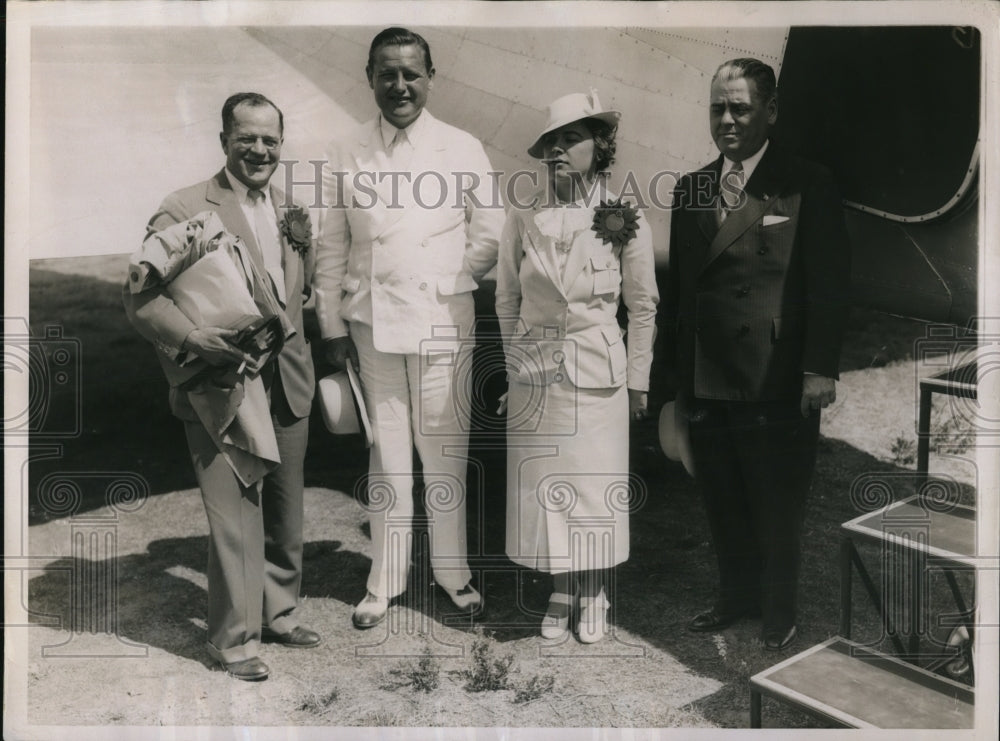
[496,91,658,643]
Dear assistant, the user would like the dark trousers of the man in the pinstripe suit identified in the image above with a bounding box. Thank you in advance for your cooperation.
[690,399,820,631]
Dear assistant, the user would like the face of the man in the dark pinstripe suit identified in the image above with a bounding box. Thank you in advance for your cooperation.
[709,77,778,162]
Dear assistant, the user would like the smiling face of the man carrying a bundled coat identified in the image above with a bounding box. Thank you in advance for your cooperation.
[219,103,281,190]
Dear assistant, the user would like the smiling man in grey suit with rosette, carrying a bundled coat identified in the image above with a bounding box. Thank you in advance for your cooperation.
[124,93,320,681]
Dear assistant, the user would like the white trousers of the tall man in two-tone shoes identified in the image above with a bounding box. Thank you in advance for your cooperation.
[350,318,474,598]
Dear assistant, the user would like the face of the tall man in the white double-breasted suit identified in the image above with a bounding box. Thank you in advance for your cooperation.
[365,44,434,129]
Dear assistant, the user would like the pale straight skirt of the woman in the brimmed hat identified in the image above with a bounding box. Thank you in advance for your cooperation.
[507,380,629,573]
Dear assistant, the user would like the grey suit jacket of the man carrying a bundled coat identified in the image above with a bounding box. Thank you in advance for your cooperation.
[123,169,315,421]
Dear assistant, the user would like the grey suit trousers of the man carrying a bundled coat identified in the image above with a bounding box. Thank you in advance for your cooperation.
[184,372,309,663]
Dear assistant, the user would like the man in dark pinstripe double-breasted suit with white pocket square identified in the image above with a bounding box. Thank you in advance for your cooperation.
[660,59,850,650]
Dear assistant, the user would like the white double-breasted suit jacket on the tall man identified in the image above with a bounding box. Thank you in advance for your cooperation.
[314,110,504,353]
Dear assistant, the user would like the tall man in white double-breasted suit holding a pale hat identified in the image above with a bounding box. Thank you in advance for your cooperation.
[315,28,503,628]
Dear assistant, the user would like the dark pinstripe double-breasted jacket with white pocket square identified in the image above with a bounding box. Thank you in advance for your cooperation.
[660,142,850,402]
